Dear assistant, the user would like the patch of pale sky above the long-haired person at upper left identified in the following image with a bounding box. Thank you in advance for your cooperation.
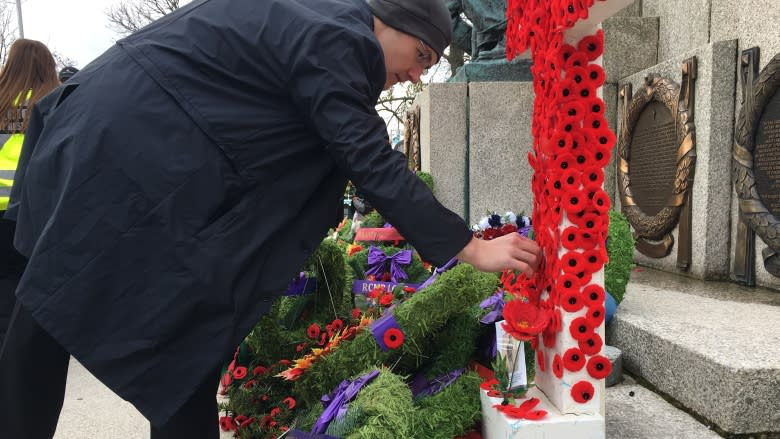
[22,0,118,68]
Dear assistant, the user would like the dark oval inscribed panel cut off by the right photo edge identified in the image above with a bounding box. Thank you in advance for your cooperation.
[753,92,780,218]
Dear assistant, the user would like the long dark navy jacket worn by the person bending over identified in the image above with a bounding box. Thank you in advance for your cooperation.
[9,0,471,424]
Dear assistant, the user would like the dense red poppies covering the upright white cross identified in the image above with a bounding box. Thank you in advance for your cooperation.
[502,0,615,403]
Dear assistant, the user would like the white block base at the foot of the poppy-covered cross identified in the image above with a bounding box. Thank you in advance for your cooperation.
[480,387,606,439]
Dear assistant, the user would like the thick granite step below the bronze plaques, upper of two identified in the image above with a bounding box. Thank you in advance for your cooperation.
[607,268,780,436]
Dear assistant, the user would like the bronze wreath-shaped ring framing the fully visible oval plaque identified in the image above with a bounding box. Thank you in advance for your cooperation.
[618,74,696,244]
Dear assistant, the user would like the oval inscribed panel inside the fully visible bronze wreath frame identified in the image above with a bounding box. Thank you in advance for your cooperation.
[628,101,678,216]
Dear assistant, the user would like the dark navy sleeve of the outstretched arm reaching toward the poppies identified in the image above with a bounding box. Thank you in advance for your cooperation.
[290,21,472,266]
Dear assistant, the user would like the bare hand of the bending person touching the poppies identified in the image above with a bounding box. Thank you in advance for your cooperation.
[456,233,542,276]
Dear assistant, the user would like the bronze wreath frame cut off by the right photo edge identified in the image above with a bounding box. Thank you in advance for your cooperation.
[732,53,780,277]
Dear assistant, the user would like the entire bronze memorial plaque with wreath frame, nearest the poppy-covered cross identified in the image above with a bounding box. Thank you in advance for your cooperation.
[617,58,696,270]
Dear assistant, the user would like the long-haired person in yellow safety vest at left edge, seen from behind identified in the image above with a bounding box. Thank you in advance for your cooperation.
[0,39,59,351]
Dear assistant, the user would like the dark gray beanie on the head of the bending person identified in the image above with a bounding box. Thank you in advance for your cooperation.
[366,0,452,59]
